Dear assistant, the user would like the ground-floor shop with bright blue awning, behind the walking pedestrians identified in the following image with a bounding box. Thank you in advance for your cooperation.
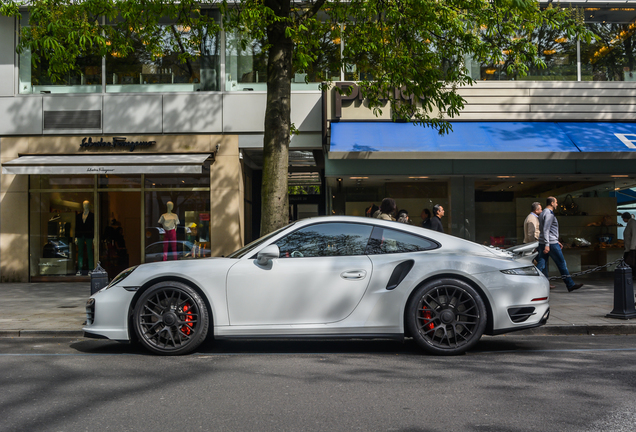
[325,88,636,271]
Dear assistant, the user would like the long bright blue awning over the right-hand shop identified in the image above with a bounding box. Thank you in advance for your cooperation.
[329,122,636,159]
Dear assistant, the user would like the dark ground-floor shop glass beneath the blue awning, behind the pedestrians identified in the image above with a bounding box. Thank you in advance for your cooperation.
[330,175,636,272]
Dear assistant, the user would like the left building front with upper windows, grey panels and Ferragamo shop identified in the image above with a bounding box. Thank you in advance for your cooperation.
[0,11,324,282]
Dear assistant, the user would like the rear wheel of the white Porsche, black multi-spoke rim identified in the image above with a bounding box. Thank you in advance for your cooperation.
[406,279,487,355]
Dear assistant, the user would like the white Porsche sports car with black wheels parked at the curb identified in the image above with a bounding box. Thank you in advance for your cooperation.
[84,216,550,355]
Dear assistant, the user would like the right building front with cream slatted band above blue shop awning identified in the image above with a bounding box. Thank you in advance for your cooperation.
[324,1,636,271]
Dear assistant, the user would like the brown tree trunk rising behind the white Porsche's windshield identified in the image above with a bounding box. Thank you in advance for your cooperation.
[261,0,293,235]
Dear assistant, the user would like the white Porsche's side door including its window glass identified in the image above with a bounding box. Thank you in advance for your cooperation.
[227,223,372,325]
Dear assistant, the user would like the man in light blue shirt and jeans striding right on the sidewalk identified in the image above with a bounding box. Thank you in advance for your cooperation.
[537,197,583,292]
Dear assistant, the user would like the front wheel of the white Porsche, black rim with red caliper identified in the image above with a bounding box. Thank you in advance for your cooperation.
[133,281,210,355]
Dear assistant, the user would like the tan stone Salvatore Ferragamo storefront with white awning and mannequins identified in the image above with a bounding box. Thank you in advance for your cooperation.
[0,135,244,282]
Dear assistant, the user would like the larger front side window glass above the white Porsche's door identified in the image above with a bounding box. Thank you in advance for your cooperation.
[276,223,373,258]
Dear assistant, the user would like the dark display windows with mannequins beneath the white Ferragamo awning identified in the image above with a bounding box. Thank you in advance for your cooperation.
[29,172,210,280]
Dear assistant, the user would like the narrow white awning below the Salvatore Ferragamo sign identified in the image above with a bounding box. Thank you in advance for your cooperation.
[2,153,211,175]
